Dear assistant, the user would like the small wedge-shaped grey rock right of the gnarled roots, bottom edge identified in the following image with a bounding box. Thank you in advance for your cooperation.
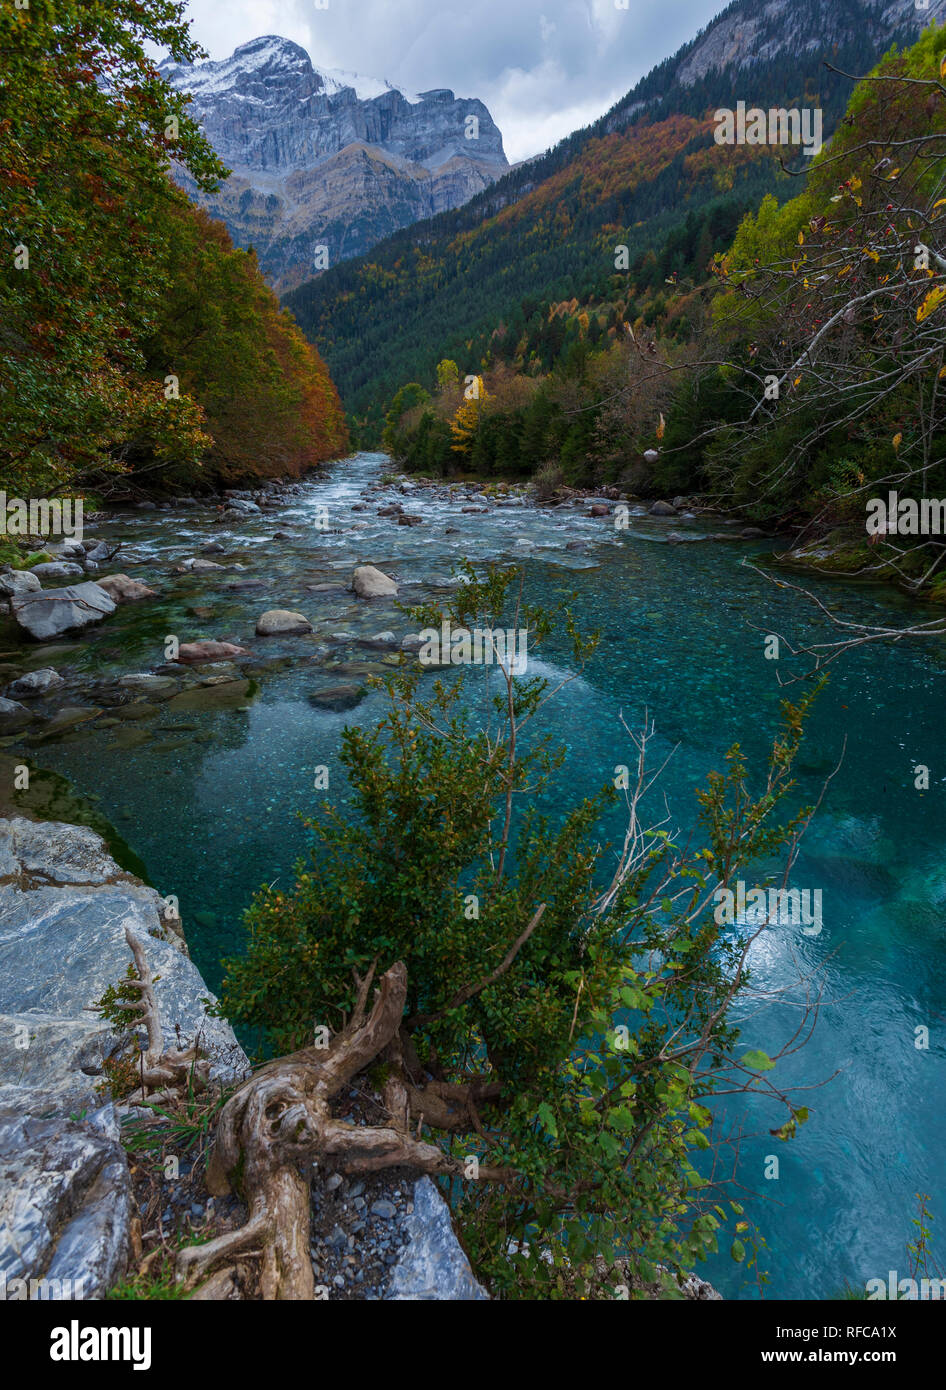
[386,1177,489,1302]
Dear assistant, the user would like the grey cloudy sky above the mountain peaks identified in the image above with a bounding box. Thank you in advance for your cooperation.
[177,0,727,161]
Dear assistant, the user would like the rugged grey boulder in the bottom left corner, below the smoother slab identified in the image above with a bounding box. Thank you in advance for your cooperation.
[0,1087,132,1298]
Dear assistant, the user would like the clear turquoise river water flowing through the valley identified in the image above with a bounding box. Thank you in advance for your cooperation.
[9,456,946,1298]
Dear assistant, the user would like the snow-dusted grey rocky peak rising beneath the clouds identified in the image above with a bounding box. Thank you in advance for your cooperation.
[161,35,508,289]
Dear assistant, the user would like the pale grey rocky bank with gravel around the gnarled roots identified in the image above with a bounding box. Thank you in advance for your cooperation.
[0,817,486,1300]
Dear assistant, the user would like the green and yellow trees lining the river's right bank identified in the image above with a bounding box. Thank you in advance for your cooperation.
[383,26,946,598]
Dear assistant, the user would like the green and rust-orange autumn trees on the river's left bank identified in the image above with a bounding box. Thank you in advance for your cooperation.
[0,0,347,496]
